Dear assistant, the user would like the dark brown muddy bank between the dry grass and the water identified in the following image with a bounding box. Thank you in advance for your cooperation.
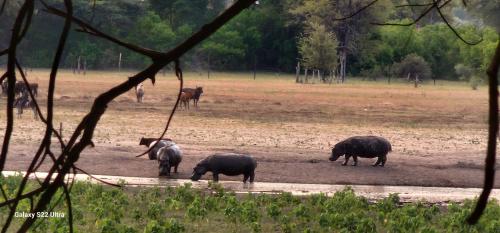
[6,144,500,188]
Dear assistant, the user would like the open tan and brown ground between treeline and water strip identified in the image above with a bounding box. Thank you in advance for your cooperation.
[0,71,500,188]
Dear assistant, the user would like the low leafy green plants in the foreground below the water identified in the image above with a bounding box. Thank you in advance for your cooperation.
[0,176,500,233]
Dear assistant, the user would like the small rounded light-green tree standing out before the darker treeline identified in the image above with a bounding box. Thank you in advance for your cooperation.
[298,22,337,79]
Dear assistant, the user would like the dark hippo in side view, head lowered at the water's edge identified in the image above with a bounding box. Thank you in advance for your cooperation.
[191,153,257,183]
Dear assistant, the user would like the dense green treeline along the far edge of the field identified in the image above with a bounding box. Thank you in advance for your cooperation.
[0,0,498,80]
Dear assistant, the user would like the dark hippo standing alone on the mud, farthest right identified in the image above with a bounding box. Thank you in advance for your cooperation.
[330,136,392,167]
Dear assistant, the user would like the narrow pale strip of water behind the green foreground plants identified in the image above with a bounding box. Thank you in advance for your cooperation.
[3,171,500,203]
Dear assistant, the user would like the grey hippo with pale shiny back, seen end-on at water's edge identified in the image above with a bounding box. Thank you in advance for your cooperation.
[156,141,182,176]
